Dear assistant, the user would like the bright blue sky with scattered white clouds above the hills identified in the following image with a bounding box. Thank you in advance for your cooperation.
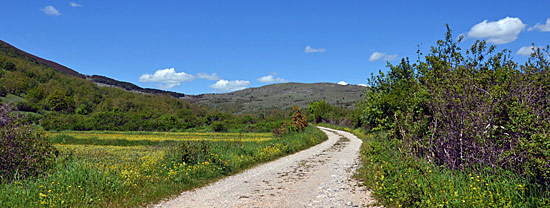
[0,0,550,94]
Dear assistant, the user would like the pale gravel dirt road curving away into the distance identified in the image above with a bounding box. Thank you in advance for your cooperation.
[155,127,380,208]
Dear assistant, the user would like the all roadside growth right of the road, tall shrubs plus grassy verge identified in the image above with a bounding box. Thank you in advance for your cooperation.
[310,26,550,207]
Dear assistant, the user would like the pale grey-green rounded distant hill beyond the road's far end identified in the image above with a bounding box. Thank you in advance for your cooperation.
[183,83,366,113]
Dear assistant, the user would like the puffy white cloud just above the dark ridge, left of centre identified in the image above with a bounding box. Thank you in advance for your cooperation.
[138,68,195,89]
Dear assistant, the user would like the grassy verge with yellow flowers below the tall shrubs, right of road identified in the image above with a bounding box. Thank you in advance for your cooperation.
[320,124,550,207]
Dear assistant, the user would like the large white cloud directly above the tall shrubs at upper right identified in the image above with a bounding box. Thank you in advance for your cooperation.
[468,17,527,44]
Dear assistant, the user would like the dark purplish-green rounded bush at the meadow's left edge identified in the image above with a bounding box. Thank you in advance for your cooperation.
[0,104,57,183]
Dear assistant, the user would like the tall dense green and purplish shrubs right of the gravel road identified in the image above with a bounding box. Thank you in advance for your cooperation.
[363,26,550,186]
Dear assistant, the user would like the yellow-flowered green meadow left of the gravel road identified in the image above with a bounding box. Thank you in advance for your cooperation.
[0,127,326,207]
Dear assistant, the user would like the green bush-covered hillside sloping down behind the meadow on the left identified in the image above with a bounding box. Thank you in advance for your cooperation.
[0,39,207,131]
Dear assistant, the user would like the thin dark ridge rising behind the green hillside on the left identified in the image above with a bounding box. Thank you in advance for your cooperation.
[0,40,185,98]
